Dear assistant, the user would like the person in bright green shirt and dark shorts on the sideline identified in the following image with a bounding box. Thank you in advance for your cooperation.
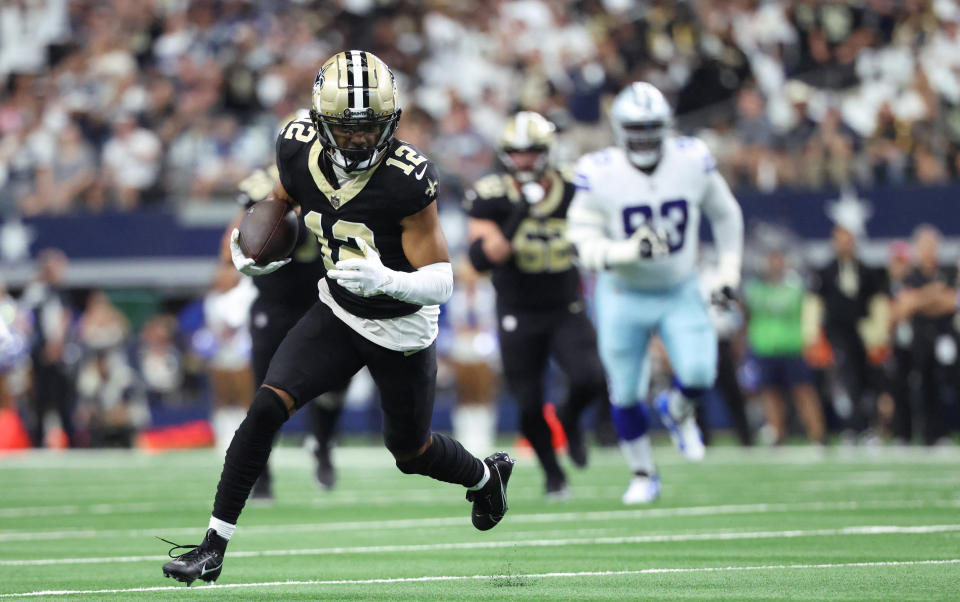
[743,241,824,444]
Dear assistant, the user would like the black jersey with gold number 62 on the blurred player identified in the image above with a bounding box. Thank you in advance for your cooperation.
[464,169,580,309]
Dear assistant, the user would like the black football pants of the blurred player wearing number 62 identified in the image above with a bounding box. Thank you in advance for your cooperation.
[498,302,607,481]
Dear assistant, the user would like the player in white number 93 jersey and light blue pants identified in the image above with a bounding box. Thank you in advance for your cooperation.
[568,82,743,504]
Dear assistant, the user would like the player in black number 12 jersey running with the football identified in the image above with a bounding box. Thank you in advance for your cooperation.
[163,50,513,583]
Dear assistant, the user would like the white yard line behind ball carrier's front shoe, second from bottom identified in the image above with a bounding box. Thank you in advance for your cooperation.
[0,524,960,566]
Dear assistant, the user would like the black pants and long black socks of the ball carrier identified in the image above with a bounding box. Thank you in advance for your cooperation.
[213,301,485,523]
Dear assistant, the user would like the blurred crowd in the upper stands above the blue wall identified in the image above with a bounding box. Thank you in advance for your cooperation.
[0,0,960,215]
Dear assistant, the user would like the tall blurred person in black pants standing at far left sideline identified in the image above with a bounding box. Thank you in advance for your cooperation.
[20,249,74,447]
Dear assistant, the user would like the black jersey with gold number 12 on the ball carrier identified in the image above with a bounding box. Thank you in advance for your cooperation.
[277,120,439,319]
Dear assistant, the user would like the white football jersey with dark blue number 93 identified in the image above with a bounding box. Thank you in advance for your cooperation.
[571,136,742,290]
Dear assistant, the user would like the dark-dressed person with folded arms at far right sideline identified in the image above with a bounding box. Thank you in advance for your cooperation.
[892,225,958,445]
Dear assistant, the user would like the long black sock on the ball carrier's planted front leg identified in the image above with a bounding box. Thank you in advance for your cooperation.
[213,387,289,525]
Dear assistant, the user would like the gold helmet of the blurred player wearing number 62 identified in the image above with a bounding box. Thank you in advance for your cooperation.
[497,111,556,184]
